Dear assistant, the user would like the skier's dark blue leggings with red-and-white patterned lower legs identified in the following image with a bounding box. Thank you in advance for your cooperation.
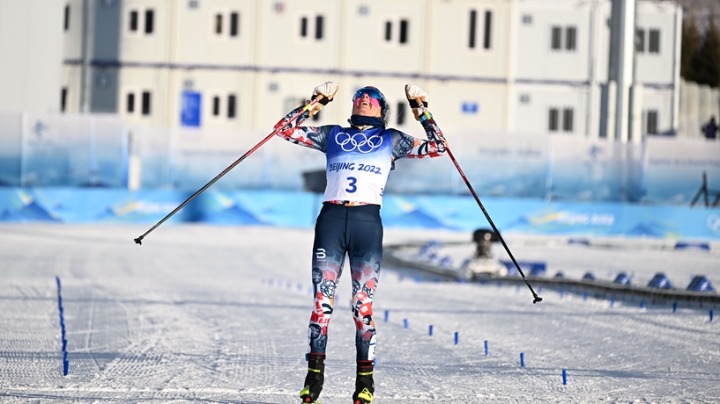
[308,203,383,360]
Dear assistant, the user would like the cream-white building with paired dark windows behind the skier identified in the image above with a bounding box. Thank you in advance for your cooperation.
[28,0,696,141]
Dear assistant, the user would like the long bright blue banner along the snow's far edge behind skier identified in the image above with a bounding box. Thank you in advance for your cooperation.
[0,187,720,241]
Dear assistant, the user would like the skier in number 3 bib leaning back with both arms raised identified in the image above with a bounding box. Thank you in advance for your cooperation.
[278,82,445,404]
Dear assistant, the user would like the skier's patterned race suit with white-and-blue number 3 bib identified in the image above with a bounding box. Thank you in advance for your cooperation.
[278,107,445,360]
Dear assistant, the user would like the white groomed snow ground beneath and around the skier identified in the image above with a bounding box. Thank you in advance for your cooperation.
[0,224,720,404]
